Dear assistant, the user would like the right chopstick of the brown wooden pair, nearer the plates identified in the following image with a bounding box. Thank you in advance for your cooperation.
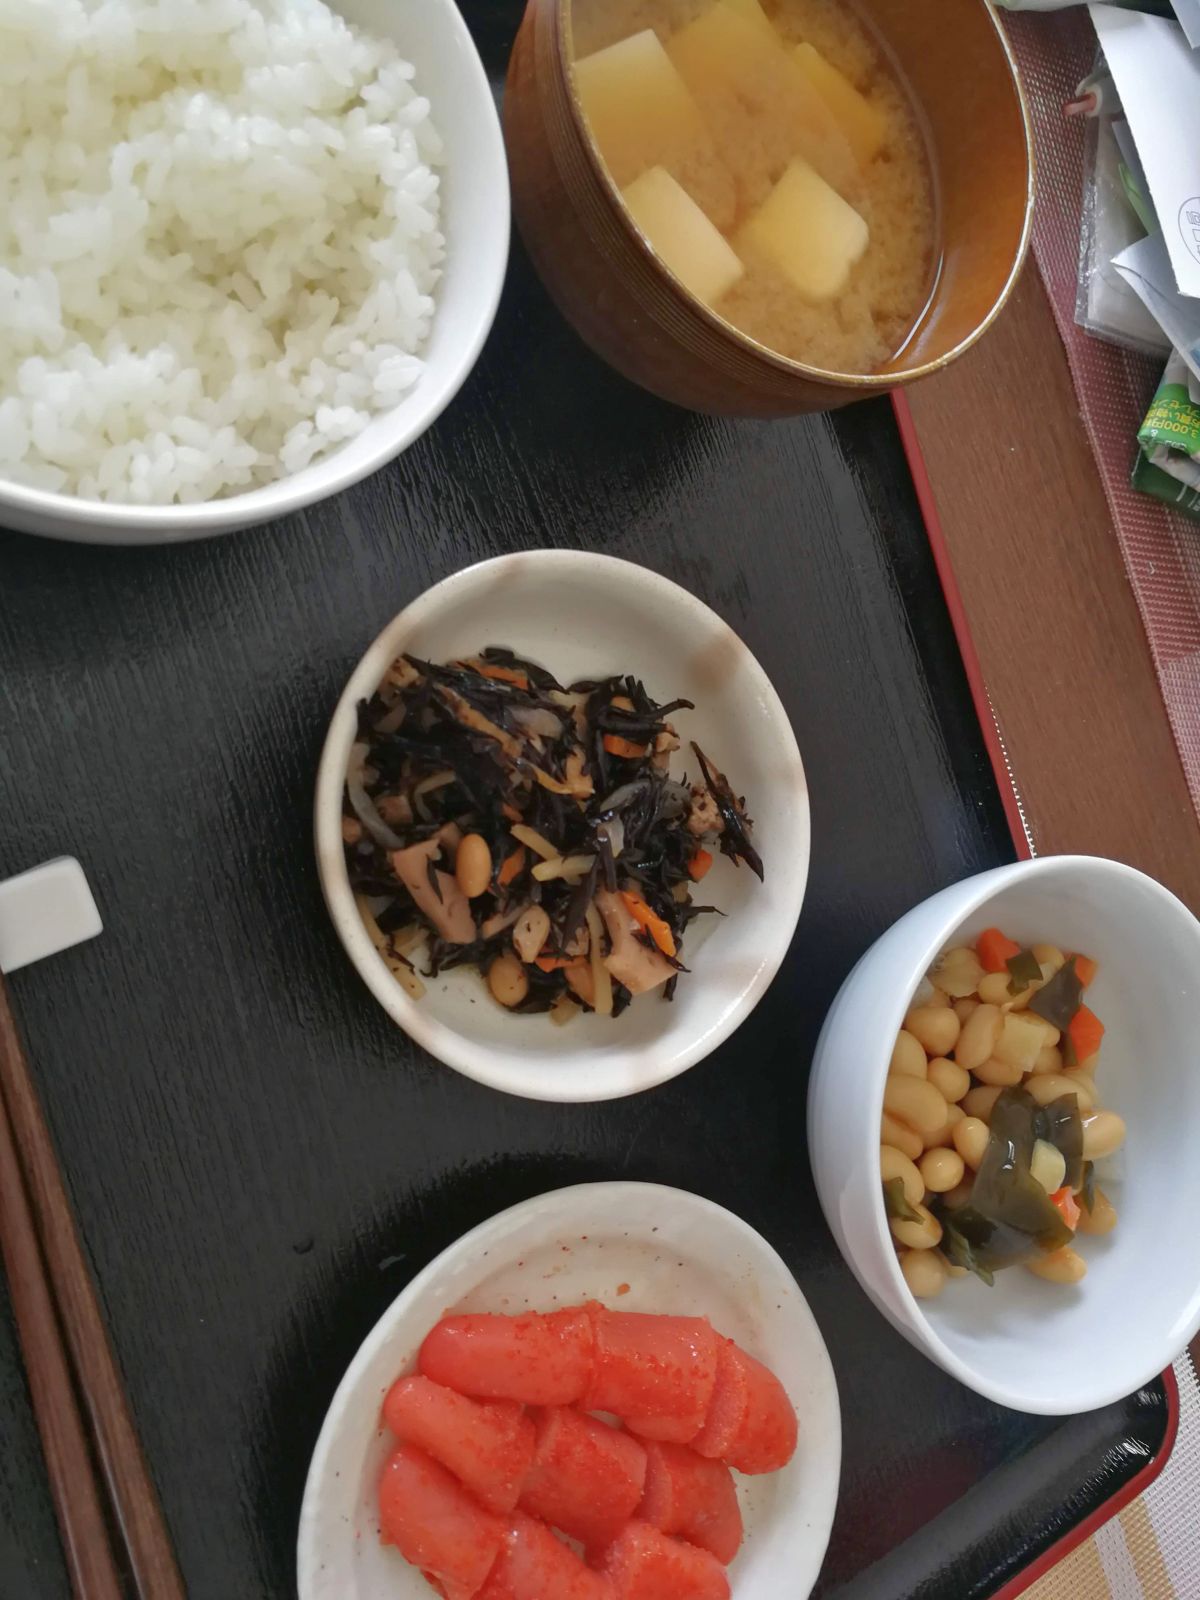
[0,979,186,1600]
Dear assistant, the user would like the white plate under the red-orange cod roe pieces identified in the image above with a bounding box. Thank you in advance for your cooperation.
[298,1182,842,1600]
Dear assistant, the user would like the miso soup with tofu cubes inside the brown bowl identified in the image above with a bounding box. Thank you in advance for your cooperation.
[573,0,938,373]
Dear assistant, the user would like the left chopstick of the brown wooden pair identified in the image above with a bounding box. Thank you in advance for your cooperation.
[0,1062,122,1600]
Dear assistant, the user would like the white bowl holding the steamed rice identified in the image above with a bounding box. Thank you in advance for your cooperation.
[0,0,510,544]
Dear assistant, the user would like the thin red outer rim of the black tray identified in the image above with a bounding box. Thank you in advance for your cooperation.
[891,389,1179,1600]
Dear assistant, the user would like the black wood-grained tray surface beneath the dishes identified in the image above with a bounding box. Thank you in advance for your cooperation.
[0,0,1168,1600]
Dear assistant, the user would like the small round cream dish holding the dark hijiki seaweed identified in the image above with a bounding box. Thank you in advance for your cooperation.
[315,550,810,1101]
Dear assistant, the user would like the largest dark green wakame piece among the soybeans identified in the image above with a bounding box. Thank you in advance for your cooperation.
[954,1090,1072,1270]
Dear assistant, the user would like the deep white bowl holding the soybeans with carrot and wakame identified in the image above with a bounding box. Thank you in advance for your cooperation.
[808,856,1200,1414]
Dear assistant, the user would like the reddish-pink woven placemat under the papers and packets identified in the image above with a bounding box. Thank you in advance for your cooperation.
[1008,8,1200,825]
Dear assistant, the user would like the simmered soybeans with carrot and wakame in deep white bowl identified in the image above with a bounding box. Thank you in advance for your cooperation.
[880,928,1125,1299]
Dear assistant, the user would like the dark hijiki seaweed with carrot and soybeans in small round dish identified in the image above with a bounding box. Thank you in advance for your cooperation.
[342,646,763,1022]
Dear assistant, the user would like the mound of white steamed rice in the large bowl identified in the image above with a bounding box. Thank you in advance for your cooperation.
[0,0,445,504]
